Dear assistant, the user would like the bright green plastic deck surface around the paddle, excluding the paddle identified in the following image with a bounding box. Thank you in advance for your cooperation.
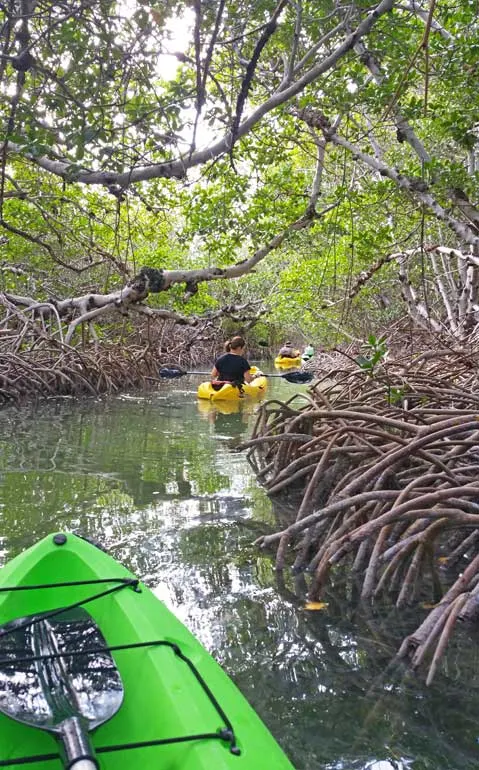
[0,534,293,770]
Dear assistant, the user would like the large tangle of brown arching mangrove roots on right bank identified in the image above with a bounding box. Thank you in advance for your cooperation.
[242,350,479,683]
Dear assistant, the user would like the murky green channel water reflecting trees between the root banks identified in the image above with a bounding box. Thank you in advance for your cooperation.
[0,370,479,770]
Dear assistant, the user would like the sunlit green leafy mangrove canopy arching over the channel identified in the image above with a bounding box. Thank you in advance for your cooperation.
[0,0,479,344]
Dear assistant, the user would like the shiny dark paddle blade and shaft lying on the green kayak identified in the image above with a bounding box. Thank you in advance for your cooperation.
[0,607,123,770]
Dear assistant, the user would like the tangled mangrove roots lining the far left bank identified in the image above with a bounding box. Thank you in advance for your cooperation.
[0,292,228,406]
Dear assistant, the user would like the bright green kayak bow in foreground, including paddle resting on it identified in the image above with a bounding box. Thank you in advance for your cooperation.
[0,533,294,770]
